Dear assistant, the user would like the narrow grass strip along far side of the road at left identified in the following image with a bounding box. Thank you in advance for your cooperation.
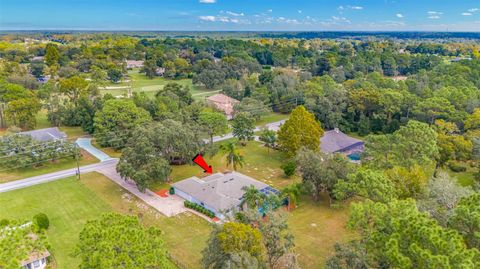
[0,150,98,183]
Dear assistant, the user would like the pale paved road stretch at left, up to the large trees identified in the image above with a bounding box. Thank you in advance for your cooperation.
[0,159,118,193]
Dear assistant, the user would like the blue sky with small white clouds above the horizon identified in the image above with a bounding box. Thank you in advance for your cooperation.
[0,0,480,32]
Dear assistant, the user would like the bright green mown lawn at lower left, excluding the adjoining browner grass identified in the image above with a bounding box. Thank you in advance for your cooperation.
[0,173,110,269]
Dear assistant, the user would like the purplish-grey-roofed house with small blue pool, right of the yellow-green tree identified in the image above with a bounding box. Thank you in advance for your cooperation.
[320,128,365,160]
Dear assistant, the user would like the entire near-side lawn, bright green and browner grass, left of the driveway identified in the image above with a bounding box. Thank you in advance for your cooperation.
[0,173,210,269]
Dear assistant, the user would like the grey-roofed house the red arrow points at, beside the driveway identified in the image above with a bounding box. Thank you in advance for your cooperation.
[172,172,279,219]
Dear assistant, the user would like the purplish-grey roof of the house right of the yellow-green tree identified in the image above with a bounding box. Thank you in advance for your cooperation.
[320,129,364,153]
